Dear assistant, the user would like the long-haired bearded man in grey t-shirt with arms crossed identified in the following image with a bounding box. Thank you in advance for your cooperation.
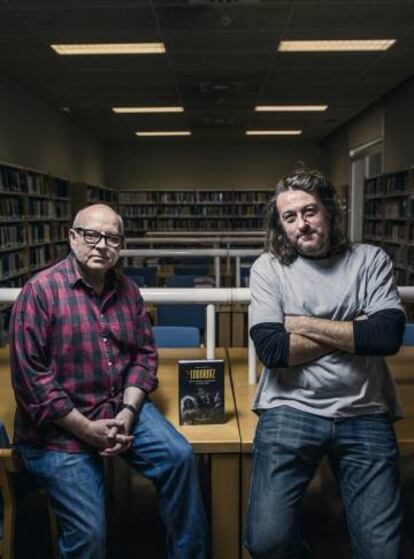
[246,170,405,559]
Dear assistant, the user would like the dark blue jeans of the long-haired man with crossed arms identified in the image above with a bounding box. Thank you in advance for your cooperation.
[246,406,402,559]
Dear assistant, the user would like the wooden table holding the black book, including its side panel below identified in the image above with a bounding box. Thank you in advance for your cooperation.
[153,348,240,559]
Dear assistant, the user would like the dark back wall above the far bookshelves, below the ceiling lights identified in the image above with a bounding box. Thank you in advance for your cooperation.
[106,138,324,189]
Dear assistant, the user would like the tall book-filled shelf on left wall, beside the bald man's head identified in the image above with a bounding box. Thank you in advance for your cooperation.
[0,164,71,344]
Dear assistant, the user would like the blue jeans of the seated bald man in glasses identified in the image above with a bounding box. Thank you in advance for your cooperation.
[19,400,209,559]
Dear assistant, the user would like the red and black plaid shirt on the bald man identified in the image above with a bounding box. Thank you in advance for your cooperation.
[10,254,158,452]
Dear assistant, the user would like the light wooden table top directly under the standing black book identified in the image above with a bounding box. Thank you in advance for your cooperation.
[152,348,240,453]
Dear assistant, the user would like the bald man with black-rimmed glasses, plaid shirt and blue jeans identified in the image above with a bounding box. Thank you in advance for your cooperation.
[11,204,208,559]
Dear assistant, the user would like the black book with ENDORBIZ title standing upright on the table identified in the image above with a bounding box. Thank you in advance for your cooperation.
[178,359,226,425]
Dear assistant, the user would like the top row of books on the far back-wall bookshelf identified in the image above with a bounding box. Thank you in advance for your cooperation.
[119,190,272,204]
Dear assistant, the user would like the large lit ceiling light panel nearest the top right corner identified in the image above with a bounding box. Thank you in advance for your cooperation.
[278,39,395,52]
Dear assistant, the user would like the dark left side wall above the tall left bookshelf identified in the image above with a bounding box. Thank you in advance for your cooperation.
[0,72,105,185]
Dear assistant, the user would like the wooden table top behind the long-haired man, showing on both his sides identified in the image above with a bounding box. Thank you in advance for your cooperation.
[228,347,414,452]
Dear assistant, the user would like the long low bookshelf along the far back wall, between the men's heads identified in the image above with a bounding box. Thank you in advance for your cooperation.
[119,190,273,237]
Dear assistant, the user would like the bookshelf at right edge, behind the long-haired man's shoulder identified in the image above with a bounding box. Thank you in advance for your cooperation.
[363,169,414,285]
